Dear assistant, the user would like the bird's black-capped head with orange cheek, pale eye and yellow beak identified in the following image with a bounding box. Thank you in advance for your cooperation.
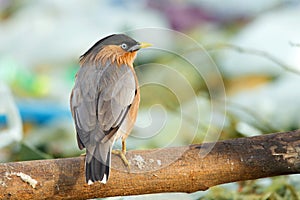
[80,34,151,66]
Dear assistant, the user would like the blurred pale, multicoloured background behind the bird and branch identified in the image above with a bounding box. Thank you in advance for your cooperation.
[0,0,300,199]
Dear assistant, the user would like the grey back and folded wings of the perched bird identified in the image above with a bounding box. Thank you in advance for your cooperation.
[70,63,136,149]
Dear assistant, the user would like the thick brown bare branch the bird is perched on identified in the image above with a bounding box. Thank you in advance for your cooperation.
[0,130,300,199]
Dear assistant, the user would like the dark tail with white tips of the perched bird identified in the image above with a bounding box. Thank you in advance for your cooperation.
[85,142,112,184]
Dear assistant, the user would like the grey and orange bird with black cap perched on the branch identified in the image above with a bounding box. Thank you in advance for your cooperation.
[70,34,151,185]
